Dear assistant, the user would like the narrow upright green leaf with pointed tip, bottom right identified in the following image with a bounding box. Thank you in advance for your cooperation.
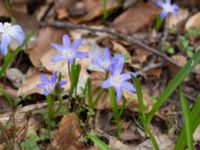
[180,90,194,150]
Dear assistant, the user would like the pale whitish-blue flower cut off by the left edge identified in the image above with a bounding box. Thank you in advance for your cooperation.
[0,22,25,56]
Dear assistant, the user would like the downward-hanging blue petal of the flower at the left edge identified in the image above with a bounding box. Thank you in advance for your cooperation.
[1,33,11,56]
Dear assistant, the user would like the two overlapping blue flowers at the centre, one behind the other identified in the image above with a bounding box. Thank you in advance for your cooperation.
[92,48,136,101]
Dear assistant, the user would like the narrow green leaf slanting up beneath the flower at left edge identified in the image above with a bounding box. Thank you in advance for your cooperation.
[0,32,35,77]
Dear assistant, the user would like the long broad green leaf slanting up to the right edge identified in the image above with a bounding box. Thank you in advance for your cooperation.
[147,50,200,124]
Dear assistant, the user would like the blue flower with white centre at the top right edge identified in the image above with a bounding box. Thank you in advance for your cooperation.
[156,0,179,19]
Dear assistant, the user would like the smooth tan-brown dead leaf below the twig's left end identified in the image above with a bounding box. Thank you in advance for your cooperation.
[29,27,67,68]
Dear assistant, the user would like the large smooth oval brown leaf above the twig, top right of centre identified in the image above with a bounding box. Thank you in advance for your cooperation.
[113,3,160,34]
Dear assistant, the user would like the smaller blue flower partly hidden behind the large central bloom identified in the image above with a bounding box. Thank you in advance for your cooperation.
[92,48,112,72]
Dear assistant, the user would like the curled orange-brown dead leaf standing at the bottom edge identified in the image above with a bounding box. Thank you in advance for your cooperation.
[51,113,85,150]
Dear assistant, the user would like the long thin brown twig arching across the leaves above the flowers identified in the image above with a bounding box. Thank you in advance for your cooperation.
[40,21,199,74]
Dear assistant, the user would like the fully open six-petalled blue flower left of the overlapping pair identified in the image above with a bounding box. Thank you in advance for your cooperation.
[51,34,88,65]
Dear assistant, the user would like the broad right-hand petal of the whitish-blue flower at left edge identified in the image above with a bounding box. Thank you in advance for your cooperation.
[8,25,25,44]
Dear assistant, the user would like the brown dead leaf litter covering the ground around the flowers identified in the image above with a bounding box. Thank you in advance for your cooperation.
[0,0,200,150]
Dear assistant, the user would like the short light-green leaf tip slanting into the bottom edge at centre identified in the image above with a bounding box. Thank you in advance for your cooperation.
[87,133,112,150]
